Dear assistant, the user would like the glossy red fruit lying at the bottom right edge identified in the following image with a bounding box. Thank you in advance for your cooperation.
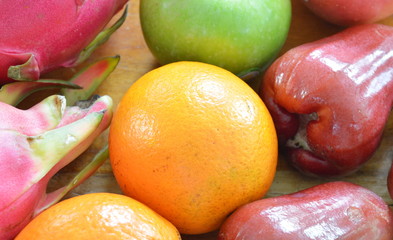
[218,182,393,240]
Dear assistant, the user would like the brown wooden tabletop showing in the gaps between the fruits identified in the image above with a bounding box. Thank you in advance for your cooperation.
[39,0,393,240]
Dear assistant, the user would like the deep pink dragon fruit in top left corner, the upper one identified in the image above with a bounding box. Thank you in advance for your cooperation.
[0,0,127,86]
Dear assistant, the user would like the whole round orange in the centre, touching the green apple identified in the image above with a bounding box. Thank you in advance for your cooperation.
[109,62,278,234]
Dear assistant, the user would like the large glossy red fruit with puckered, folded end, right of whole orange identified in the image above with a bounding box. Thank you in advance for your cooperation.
[260,24,393,177]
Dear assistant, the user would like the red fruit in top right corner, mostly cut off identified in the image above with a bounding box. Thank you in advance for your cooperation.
[302,0,393,26]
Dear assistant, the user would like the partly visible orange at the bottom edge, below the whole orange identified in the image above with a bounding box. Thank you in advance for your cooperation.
[15,193,180,240]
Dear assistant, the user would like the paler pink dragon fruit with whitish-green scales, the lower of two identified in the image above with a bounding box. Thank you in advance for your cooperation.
[0,53,120,239]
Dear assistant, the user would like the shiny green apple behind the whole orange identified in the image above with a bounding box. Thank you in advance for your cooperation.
[140,0,291,74]
